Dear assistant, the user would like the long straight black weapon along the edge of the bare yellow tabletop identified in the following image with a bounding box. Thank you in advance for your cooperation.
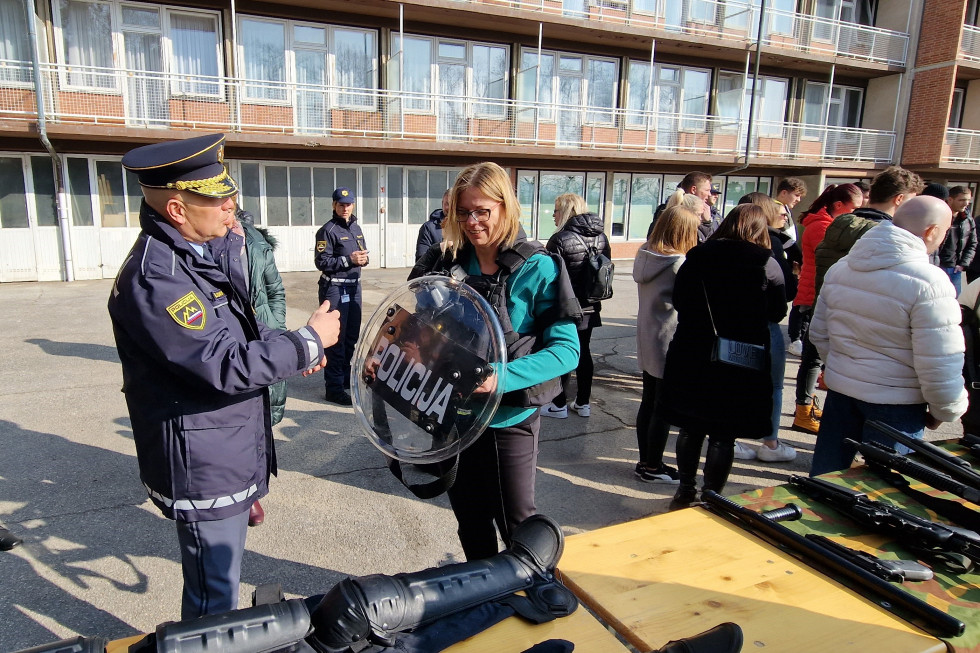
[701,490,966,637]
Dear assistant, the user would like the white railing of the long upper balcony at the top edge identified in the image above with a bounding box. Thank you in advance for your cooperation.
[460,0,909,66]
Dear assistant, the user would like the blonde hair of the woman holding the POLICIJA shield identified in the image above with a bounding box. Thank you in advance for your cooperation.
[442,161,521,258]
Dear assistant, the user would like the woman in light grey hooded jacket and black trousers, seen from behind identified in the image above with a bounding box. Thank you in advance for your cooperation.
[633,206,701,483]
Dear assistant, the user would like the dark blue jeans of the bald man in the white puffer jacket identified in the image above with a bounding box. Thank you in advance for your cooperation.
[810,390,926,476]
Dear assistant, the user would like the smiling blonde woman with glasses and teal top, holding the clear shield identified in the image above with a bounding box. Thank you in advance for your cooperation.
[410,162,580,560]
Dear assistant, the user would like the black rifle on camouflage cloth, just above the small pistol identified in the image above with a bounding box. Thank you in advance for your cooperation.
[789,474,980,562]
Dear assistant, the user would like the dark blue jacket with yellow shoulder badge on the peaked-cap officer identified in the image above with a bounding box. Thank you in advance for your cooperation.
[109,203,323,521]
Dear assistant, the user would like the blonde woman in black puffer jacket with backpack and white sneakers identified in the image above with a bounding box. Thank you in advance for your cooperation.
[541,193,610,418]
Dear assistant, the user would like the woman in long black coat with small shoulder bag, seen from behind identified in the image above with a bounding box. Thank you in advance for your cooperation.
[658,204,786,510]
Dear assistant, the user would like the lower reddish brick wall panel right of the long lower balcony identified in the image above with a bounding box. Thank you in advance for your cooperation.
[902,65,956,166]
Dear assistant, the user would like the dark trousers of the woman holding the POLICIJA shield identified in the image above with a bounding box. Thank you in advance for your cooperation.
[449,411,541,560]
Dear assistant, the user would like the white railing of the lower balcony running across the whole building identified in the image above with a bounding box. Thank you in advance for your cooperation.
[0,64,895,163]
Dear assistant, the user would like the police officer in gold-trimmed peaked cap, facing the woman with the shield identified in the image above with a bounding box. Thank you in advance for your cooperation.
[109,134,339,619]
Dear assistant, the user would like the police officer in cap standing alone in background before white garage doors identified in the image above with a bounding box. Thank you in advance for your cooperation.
[313,188,368,406]
